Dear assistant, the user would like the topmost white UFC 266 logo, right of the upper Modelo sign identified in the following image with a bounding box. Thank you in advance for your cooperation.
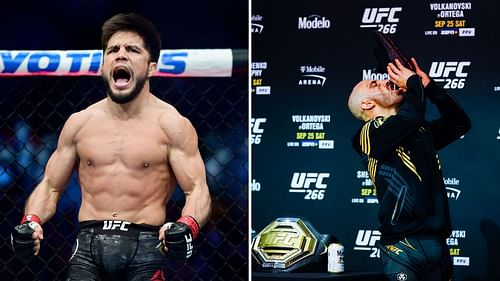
[359,7,403,34]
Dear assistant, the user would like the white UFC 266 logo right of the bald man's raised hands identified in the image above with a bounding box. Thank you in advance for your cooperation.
[429,61,470,89]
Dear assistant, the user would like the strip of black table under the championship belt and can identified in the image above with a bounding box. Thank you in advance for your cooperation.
[252,272,387,281]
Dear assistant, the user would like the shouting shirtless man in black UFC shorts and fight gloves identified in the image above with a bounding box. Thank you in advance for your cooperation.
[12,14,211,280]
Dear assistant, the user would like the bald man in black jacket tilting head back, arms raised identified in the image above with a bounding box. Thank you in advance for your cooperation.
[348,59,471,281]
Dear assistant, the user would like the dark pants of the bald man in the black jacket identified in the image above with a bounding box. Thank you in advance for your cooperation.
[380,235,453,281]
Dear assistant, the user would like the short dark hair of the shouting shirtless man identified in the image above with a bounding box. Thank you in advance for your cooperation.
[101,13,161,62]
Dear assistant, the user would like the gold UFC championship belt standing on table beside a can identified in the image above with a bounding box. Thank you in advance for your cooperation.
[252,217,330,272]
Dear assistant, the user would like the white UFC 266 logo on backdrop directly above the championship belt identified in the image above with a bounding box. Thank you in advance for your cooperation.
[289,173,330,200]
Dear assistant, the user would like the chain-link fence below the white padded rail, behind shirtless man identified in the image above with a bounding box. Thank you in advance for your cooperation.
[0,73,248,281]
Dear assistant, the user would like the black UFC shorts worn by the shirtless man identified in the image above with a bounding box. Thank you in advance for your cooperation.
[66,221,166,281]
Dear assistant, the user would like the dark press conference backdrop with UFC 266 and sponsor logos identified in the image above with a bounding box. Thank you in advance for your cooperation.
[250,0,500,280]
